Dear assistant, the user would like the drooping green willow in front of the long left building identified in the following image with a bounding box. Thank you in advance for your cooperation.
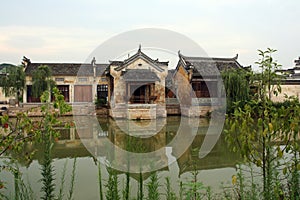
[32,65,55,97]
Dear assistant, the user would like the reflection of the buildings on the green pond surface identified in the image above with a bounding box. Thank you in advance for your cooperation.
[14,116,240,178]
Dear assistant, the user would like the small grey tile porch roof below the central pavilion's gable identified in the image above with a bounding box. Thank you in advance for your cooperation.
[123,69,159,82]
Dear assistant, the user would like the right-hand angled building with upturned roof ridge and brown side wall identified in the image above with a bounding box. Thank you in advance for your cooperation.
[174,52,243,117]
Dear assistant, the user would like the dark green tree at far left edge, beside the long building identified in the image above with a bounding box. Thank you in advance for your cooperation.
[0,65,25,102]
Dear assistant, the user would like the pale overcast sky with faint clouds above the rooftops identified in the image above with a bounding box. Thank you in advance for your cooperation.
[0,0,300,68]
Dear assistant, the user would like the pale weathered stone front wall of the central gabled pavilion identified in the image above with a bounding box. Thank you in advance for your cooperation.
[109,58,168,119]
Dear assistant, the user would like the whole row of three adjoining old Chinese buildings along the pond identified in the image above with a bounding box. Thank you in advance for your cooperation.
[23,46,243,119]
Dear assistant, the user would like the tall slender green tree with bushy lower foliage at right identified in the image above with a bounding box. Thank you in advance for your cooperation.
[225,49,300,199]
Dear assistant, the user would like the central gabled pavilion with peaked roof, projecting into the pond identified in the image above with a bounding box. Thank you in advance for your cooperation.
[107,47,168,119]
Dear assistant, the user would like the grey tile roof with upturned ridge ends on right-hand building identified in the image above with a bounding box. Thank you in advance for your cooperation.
[179,54,243,76]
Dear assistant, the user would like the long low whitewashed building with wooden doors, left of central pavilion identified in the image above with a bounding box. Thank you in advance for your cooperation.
[23,58,108,103]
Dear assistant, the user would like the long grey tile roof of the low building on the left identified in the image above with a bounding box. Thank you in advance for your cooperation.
[25,63,108,76]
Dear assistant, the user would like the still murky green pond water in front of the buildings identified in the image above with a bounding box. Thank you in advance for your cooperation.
[1,116,241,200]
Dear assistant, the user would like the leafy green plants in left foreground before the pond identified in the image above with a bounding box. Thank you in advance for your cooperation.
[0,89,76,199]
